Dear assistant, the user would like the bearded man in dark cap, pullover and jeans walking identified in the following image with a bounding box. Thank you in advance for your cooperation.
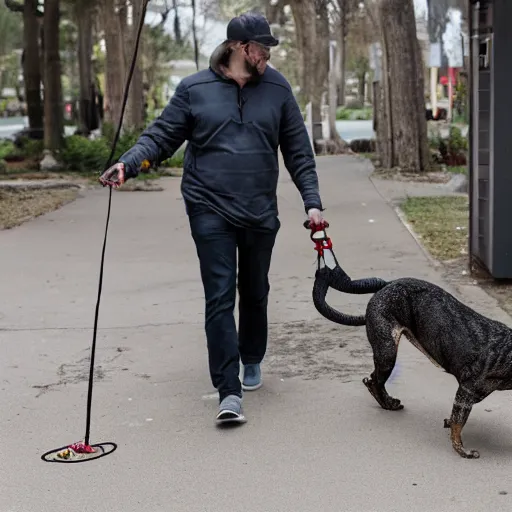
[100,13,323,423]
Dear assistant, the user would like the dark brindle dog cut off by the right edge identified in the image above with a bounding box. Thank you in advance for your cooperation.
[315,268,512,458]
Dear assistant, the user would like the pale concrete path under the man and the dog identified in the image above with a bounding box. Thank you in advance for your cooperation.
[0,157,512,512]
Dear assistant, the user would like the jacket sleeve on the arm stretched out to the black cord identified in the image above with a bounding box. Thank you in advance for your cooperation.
[118,83,191,179]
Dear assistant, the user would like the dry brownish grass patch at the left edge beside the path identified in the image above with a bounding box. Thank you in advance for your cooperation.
[0,189,78,229]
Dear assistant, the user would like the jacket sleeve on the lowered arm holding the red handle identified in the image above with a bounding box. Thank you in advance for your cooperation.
[279,92,323,212]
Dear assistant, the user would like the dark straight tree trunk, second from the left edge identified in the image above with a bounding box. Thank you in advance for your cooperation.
[44,0,64,151]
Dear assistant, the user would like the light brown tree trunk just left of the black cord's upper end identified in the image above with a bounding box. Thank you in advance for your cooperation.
[102,0,125,129]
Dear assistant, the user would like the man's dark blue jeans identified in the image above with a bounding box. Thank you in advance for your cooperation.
[190,212,279,400]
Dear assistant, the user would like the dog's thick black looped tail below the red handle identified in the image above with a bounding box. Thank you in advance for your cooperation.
[313,265,388,326]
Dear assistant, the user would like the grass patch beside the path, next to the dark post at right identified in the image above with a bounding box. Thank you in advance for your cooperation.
[401,196,469,261]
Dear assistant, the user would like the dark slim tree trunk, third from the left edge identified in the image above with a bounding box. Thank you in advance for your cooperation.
[76,2,97,136]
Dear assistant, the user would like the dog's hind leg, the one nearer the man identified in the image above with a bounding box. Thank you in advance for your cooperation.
[363,324,404,411]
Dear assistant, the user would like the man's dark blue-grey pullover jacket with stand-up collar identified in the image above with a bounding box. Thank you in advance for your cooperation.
[119,45,323,230]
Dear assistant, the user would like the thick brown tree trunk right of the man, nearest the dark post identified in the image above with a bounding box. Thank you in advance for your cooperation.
[380,0,430,172]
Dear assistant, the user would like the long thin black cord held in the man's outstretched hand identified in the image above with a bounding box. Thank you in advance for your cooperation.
[84,0,149,445]
